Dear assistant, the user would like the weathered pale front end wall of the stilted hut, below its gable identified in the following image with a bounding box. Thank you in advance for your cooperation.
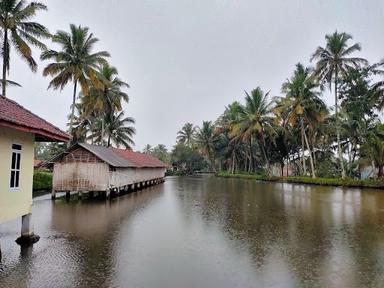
[52,162,109,191]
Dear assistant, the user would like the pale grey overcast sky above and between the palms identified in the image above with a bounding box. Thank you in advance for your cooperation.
[8,0,384,150]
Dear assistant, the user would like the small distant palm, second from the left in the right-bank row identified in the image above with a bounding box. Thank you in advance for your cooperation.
[195,121,218,171]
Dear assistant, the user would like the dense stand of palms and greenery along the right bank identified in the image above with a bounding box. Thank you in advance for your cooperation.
[165,31,384,180]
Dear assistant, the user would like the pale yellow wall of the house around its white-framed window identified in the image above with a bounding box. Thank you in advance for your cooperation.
[0,126,35,223]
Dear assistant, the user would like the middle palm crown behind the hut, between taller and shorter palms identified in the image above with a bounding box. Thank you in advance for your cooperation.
[81,63,129,115]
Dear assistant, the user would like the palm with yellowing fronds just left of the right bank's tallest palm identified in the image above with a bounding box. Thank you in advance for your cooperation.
[282,63,326,178]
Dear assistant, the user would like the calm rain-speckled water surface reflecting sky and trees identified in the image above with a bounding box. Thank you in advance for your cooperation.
[0,177,384,288]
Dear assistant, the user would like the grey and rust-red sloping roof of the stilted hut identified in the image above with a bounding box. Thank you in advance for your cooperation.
[77,143,167,168]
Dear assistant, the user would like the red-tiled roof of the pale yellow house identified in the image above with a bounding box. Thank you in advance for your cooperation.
[0,96,70,142]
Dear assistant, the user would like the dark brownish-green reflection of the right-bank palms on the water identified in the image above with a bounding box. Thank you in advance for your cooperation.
[181,178,384,287]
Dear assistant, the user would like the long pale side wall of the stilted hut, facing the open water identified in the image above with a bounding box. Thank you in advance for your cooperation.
[110,168,165,187]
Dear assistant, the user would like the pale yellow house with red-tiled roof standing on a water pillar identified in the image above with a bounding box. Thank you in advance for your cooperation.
[0,96,70,242]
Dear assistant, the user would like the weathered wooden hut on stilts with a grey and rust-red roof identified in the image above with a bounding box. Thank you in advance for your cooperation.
[52,143,166,199]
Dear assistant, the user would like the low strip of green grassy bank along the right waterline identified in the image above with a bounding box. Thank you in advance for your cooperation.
[216,172,384,189]
